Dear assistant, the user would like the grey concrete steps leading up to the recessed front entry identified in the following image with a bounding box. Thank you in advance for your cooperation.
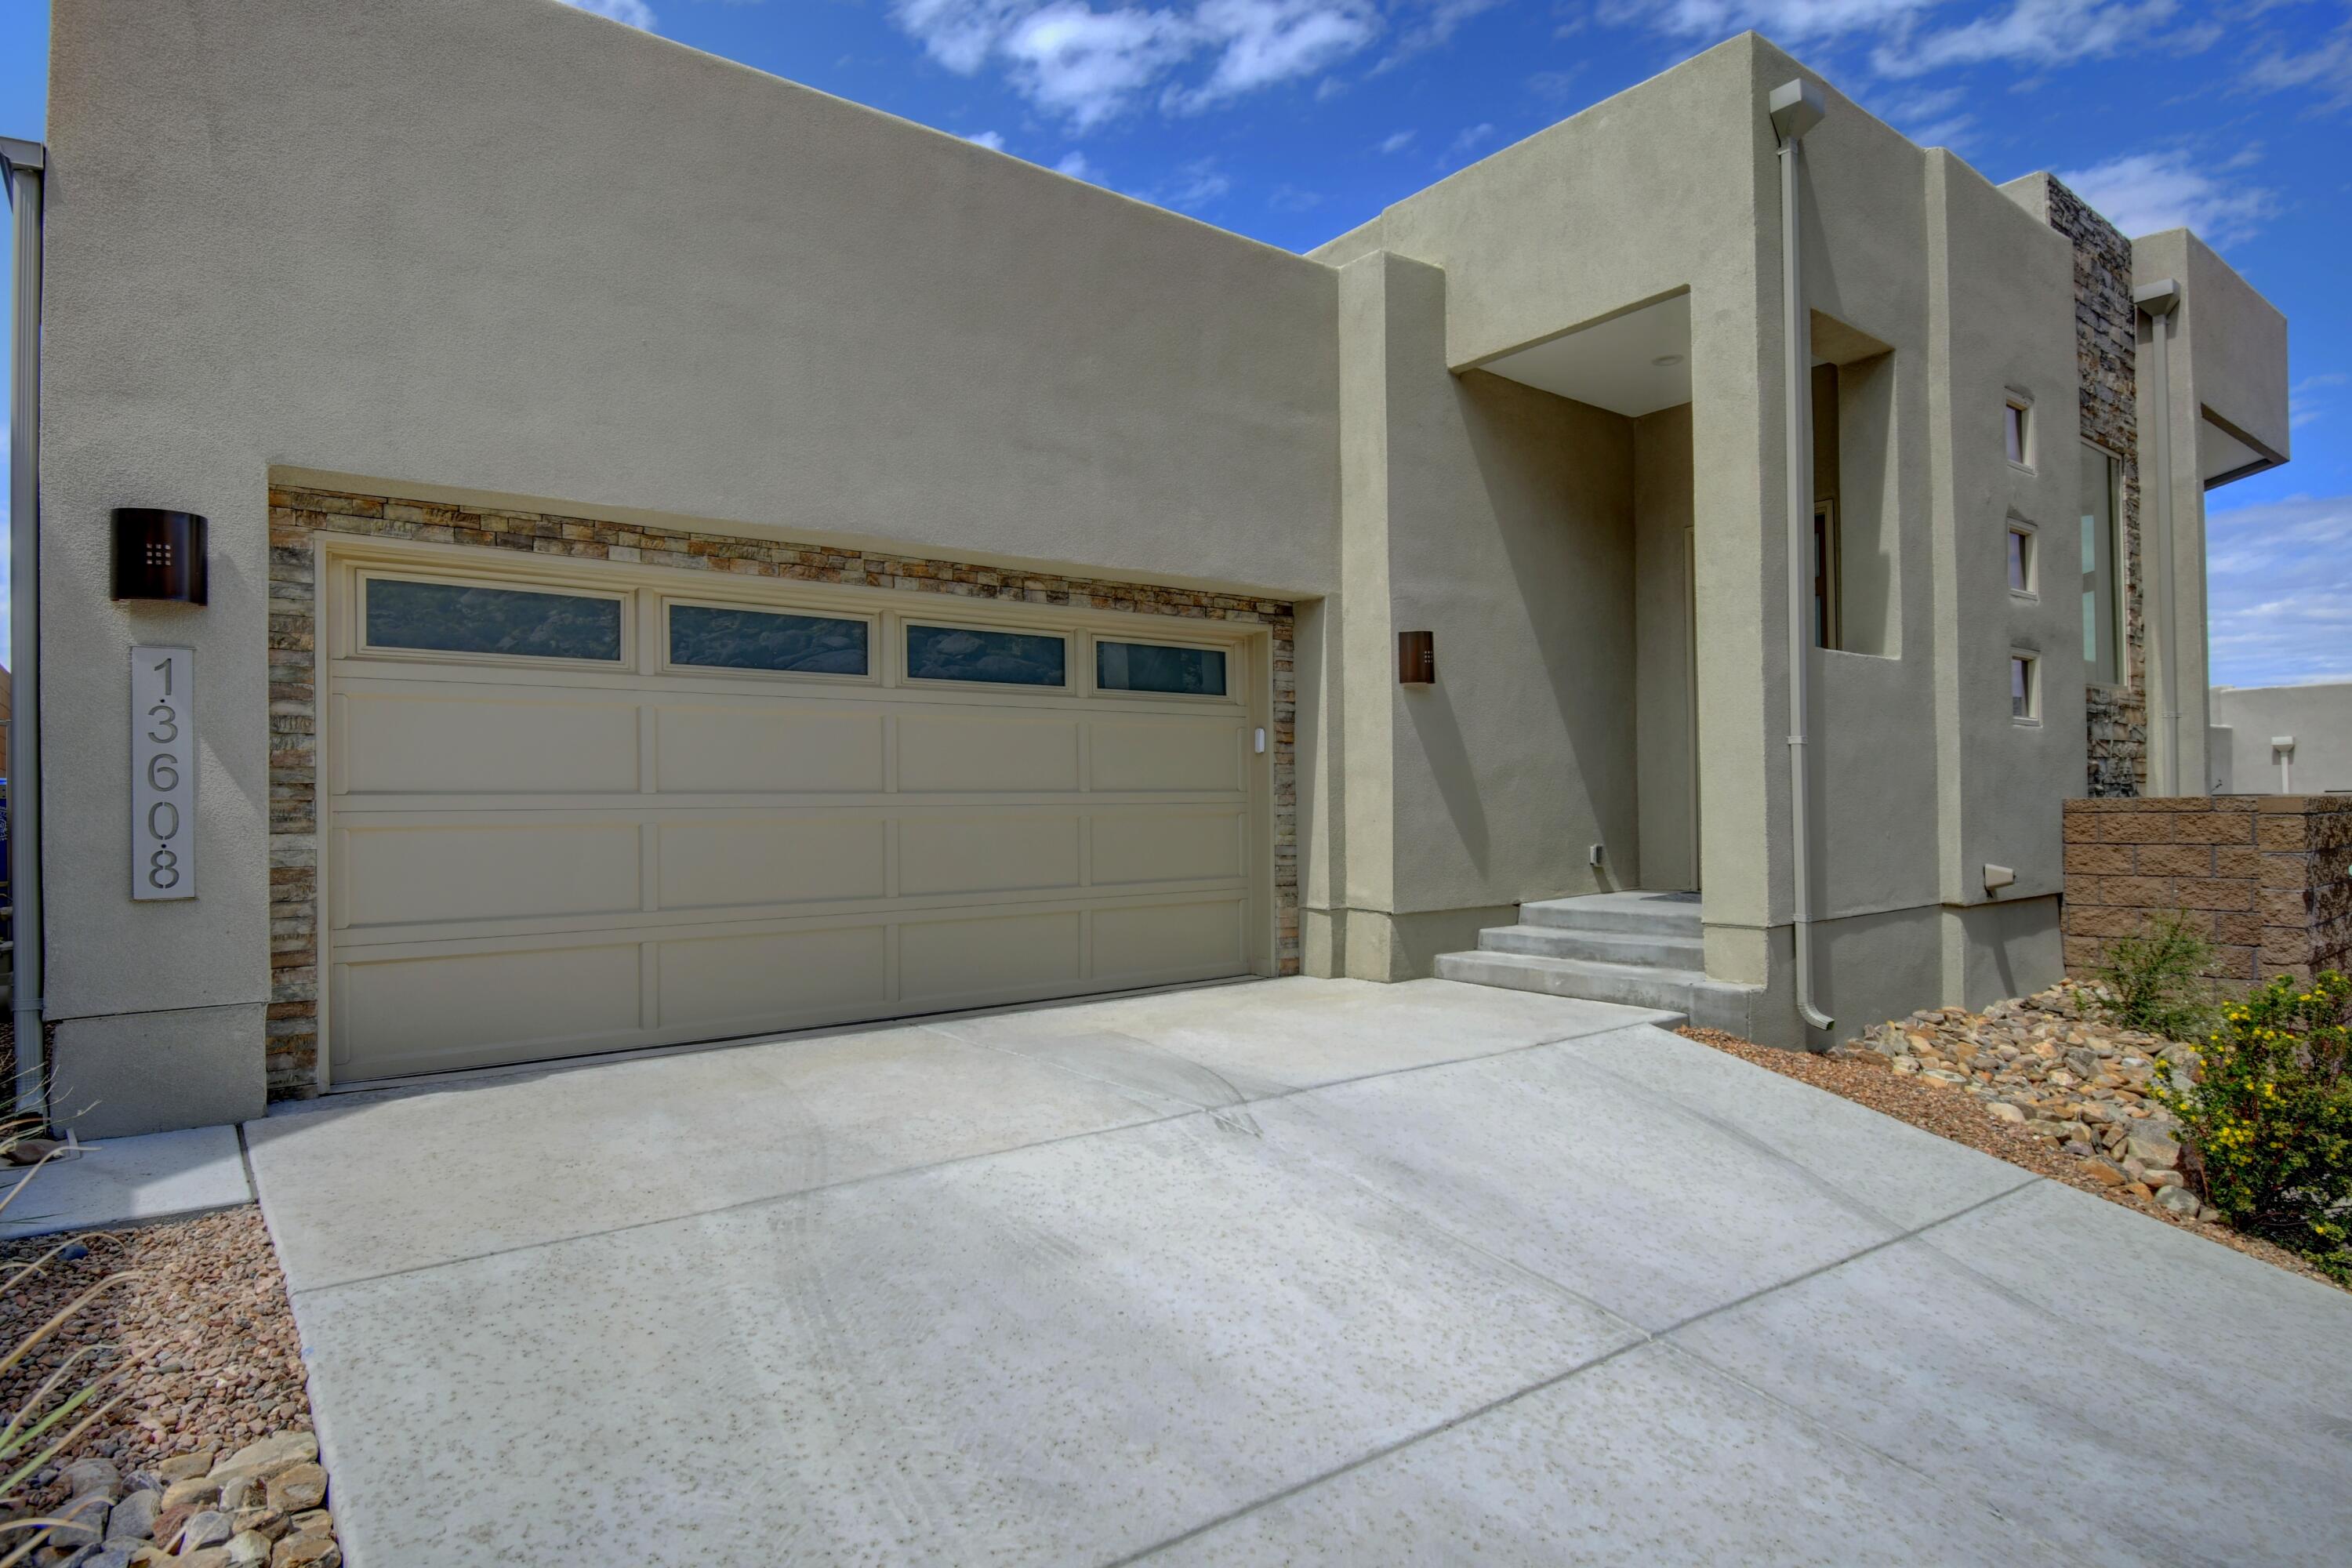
[1437,891,1764,1034]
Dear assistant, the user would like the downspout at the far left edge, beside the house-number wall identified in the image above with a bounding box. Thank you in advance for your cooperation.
[0,136,49,1126]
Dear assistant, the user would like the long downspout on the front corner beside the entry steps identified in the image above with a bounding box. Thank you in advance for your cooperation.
[1771,80,1837,1029]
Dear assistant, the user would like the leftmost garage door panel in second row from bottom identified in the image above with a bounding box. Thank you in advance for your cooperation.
[332,820,644,928]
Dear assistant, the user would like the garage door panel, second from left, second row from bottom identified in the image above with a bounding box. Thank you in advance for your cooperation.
[659,813,889,909]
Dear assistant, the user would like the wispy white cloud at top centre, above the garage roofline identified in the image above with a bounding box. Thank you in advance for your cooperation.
[891,0,1385,132]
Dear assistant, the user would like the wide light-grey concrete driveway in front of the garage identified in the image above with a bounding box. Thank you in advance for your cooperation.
[247,980,2352,1568]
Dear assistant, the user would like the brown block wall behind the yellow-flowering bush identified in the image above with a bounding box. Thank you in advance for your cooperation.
[2065,794,2352,989]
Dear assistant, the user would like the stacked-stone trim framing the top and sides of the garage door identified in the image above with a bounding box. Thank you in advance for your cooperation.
[268,487,1298,1100]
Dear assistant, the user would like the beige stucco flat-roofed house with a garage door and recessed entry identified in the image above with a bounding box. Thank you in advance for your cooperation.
[9,0,2286,1131]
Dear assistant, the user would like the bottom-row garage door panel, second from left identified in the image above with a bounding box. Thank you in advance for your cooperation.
[659,924,889,1034]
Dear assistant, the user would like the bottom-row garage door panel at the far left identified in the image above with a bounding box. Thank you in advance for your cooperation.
[334,942,642,1081]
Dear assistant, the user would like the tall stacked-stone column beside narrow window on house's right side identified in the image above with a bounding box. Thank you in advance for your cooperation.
[2042,176,2147,797]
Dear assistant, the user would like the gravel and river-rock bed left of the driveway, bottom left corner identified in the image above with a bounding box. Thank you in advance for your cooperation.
[0,1213,341,1568]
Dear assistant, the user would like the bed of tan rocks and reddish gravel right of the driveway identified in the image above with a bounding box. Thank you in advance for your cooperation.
[1677,985,2336,1283]
